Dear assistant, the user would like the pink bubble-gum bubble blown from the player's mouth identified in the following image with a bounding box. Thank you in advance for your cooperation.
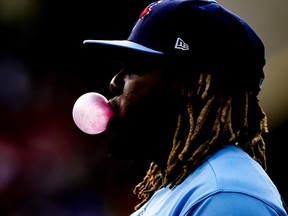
[72,92,113,134]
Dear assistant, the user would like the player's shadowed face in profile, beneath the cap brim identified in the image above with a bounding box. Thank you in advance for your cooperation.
[107,60,179,160]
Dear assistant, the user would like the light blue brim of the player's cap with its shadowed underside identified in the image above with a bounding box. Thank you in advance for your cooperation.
[83,40,163,62]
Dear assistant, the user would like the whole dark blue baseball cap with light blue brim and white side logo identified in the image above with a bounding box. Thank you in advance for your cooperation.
[84,0,265,93]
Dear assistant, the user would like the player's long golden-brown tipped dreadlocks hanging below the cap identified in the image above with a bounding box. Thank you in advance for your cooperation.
[133,73,268,210]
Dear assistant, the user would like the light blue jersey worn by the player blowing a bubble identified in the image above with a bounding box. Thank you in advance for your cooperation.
[131,145,287,216]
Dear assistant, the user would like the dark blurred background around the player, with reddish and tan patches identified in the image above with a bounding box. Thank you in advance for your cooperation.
[0,0,288,216]
